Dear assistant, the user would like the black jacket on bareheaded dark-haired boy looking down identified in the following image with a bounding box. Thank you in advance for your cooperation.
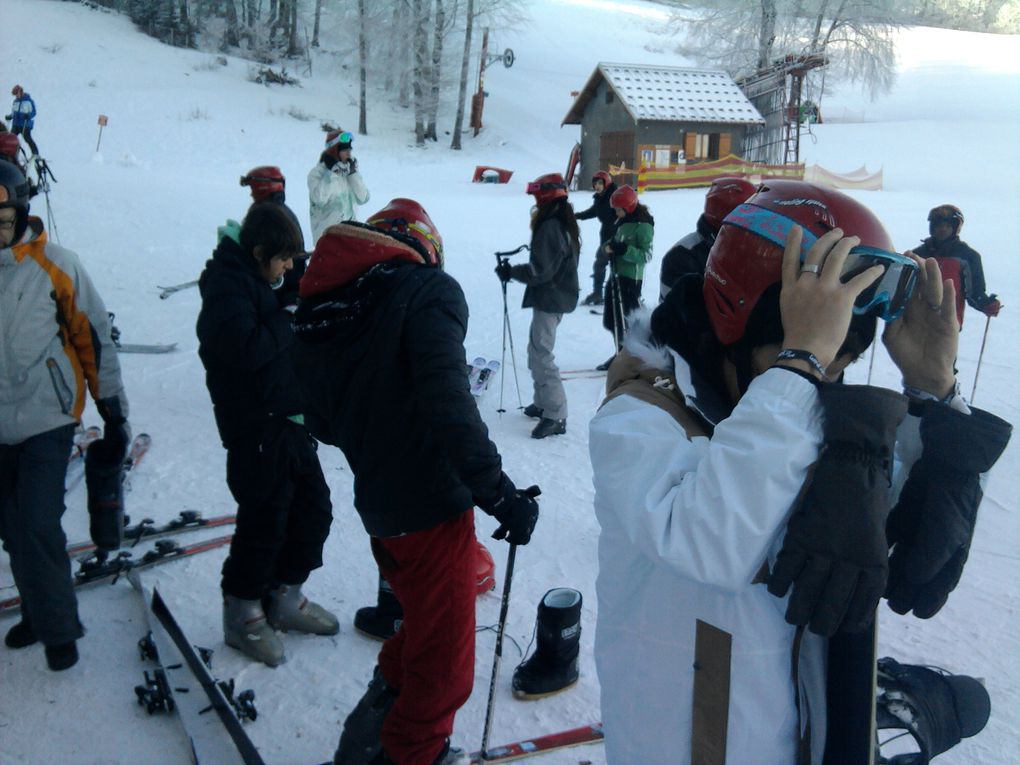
[196,237,301,448]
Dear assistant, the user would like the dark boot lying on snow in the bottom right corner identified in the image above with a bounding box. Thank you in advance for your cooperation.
[875,657,991,765]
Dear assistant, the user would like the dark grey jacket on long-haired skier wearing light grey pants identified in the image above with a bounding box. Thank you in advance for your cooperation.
[510,218,580,313]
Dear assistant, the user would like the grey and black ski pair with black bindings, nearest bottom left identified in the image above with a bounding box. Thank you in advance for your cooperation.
[128,571,262,765]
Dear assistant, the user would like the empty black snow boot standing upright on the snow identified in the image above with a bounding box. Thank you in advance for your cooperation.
[513,588,581,699]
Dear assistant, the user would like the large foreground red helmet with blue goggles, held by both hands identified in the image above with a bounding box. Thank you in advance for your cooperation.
[704,181,917,345]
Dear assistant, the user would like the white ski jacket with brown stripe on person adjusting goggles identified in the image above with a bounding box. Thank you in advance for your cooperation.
[590,341,920,765]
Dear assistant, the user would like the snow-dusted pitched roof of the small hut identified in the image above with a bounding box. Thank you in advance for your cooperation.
[563,63,765,124]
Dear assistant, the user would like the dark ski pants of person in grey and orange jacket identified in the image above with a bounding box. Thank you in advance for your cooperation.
[0,424,83,646]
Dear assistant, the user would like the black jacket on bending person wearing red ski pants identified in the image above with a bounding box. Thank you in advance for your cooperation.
[296,256,513,538]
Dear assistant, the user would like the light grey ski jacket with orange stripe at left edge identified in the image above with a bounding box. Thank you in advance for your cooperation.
[0,217,128,444]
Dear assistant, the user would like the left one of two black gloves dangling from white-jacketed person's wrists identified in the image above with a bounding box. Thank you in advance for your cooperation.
[768,384,907,636]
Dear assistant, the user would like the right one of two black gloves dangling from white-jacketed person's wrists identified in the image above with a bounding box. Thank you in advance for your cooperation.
[885,402,1013,619]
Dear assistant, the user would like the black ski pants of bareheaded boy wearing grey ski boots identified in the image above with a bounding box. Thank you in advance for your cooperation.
[220,417,333,600]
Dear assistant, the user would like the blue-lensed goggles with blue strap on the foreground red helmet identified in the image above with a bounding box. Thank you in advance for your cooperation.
[723,203,918,321]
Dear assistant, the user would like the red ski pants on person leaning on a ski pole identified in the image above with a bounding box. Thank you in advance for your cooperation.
[371,510,476,765]
